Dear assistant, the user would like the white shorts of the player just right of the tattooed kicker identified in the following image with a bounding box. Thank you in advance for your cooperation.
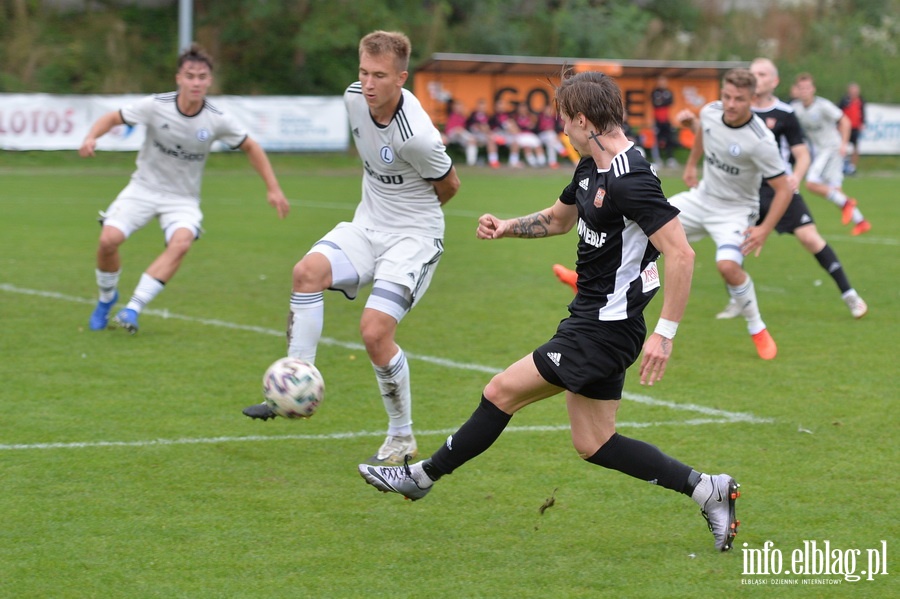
[669,187,759,264]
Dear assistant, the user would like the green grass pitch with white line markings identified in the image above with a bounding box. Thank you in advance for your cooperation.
[0,152,900,599]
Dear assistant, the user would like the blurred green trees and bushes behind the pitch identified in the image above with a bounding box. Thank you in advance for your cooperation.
[0,0,900,102]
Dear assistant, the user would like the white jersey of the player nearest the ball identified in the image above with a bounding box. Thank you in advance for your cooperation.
[344,82,453,238]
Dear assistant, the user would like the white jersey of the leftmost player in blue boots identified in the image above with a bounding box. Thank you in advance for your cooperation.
[119,92,247,202]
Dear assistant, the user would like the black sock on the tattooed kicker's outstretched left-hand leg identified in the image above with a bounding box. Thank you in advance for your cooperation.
[422,395,512,480]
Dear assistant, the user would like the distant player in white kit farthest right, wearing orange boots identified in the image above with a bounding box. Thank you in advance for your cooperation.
[791,73,872,235]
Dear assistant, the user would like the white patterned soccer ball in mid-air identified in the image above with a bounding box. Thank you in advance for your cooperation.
[263,358,325,418]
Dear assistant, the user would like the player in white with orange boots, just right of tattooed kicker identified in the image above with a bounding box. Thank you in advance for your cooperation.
[669,69,793,360]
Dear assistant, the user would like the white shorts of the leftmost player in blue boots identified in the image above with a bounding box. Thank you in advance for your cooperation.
[100,181,203,243]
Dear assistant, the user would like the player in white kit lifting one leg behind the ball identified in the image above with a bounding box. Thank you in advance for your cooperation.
[244,31,459,464]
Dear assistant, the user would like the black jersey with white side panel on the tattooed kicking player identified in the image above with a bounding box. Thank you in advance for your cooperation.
[559,145,678,321]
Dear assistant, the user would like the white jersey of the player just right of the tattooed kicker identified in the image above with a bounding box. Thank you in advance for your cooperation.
[699,101,784,207]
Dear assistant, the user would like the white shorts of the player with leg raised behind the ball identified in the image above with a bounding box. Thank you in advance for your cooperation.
[309,222,444,308]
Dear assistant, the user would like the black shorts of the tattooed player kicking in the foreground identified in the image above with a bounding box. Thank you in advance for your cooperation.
[532,316,647,399]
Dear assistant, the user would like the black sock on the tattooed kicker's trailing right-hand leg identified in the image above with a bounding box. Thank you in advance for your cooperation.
[587,433,700,497]
